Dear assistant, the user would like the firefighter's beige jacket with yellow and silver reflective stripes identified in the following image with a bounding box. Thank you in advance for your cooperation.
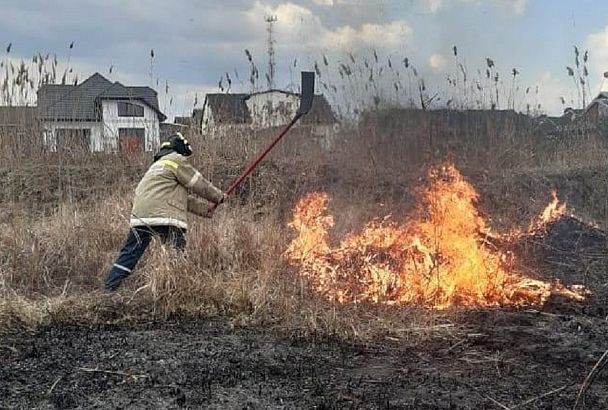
[131,153,223,229]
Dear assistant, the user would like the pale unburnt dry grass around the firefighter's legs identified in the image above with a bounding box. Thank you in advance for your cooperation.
[0,190,452,339]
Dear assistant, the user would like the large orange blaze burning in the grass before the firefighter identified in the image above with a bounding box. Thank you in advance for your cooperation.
[285,165,584,309]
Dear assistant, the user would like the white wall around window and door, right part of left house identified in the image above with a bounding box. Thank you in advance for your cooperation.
[103,100,160,151]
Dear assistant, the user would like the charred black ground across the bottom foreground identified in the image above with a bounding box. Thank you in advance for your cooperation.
[0,310,608,409]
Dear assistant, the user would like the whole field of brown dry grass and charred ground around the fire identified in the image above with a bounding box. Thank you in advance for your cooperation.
[0,110,608,409]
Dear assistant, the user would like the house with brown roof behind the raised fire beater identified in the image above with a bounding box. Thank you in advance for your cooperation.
[193,89,338,138]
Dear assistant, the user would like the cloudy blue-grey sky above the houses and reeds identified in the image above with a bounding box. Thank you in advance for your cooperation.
[0,0,608,117]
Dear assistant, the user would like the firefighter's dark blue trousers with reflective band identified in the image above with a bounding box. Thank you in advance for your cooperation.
[106,225,186,290]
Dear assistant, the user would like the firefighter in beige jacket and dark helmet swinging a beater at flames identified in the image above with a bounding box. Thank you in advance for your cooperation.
[106,133,225,291]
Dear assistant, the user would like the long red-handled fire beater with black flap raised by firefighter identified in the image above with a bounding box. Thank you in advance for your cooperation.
[208,71,315,217]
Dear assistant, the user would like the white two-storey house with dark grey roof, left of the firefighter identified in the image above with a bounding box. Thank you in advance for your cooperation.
[38,73,166,152]
